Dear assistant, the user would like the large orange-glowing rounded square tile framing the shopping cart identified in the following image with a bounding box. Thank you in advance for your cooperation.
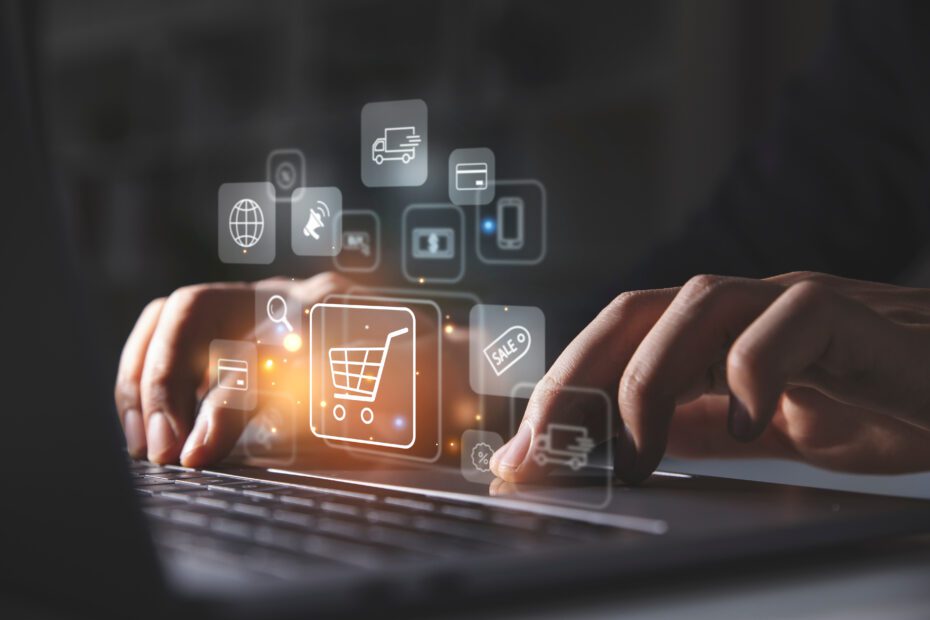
[308,303,417,448]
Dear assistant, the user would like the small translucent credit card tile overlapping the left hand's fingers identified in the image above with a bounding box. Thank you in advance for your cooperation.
[209,340,258,411]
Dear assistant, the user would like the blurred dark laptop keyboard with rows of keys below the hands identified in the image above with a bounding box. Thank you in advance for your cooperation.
[130,462,649,578]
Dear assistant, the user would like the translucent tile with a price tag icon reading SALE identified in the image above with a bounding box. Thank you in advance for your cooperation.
[468,304,546,396]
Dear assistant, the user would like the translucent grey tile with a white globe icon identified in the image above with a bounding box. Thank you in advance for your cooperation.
[217,183,275,265]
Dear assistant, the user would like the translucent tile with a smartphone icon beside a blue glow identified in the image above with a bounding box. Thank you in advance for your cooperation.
[475,179,548,265]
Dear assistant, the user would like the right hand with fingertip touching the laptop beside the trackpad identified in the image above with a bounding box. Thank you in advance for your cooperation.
[491,273,930,483]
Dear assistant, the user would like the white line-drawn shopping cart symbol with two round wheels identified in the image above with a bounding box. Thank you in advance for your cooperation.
[329,327,410,424]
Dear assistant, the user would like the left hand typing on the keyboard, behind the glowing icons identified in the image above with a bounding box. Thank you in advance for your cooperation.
[115,272,351,467]
